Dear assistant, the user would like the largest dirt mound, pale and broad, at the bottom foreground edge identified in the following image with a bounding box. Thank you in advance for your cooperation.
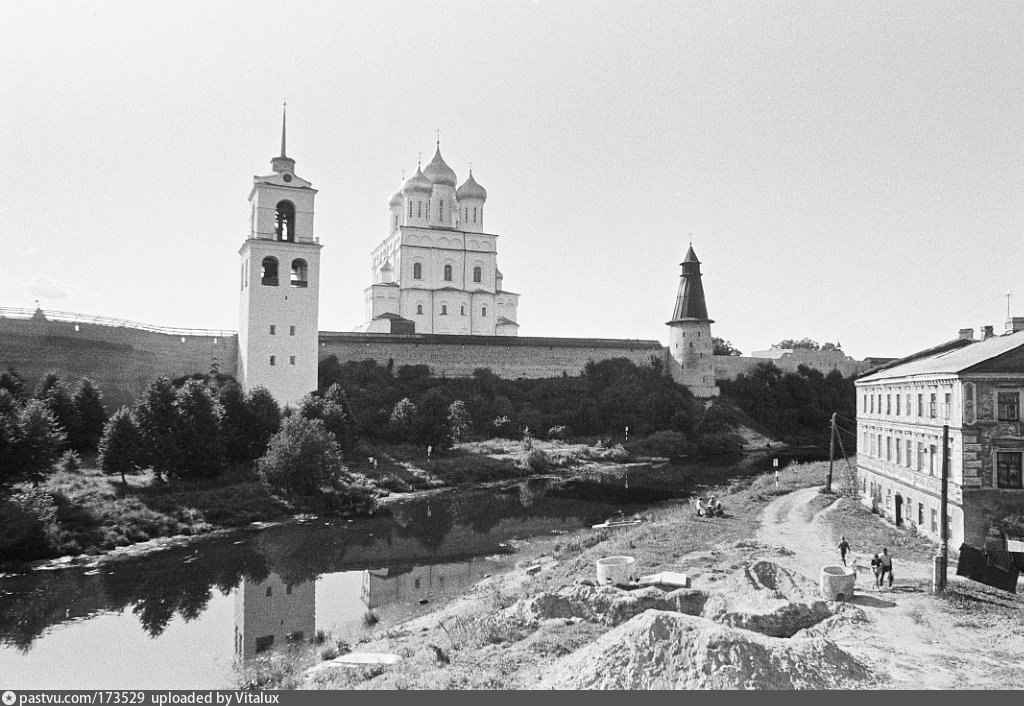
[540,611,870,689]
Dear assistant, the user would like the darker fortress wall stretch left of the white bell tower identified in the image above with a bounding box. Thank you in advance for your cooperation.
[0,317,239,412]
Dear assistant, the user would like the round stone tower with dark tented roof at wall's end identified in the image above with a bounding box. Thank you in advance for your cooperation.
[668,244,719,398]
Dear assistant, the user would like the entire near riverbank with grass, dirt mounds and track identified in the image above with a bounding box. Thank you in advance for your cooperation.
[238,463,1024,689]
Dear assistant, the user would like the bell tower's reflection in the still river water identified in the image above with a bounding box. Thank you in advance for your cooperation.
[234,573,316,660]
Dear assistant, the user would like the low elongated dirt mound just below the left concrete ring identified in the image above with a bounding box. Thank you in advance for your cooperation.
[503,586,686,625]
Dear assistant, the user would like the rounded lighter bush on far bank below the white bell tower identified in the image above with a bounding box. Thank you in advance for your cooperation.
[256,415,345,495]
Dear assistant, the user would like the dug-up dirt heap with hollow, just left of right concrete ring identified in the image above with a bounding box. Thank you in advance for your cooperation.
[701,562,833,637]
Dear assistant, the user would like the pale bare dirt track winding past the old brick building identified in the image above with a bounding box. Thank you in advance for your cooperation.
[757,488,1024,689]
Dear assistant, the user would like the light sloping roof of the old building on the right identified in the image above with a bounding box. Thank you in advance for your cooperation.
[857,331,1024,382]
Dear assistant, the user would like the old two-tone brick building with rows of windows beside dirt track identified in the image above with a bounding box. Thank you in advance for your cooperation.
[856,320,1024,547]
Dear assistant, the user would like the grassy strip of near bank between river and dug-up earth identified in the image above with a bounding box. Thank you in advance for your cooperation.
[238,463,834,689]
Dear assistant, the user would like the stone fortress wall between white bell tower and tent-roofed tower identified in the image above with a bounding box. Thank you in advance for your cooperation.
[319,331,667,378]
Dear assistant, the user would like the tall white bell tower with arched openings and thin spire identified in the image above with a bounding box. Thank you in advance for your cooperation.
[239,107,323,407]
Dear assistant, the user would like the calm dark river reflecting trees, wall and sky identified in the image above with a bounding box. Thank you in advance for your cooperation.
[0,452,818,690]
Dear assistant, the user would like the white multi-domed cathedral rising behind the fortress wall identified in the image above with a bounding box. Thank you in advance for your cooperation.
[361,141,519,336]
